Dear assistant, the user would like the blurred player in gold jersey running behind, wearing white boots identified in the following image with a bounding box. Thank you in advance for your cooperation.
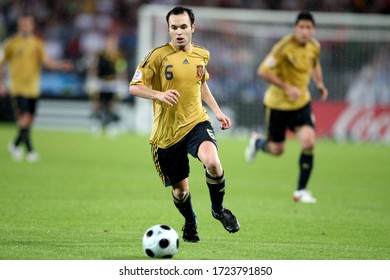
[245,12,328,203]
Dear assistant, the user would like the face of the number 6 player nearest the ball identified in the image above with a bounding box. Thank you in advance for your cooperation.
[168,13,195,51]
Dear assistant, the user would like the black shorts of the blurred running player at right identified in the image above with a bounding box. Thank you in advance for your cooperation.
[265,103,315,142]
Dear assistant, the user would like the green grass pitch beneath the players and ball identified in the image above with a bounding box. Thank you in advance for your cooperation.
[0,124,390,260]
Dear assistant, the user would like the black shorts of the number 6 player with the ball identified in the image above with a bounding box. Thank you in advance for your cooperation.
[151,121,218,187]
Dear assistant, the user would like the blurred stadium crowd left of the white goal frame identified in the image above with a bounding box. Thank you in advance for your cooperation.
[0,0,140,77]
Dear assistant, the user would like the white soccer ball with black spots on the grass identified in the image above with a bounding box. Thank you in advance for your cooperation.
[142,225,179,258]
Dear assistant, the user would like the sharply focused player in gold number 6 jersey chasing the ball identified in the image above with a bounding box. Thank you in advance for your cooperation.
[129,6,240,242]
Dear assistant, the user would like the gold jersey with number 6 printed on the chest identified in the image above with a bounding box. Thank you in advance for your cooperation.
[130,43,210,148]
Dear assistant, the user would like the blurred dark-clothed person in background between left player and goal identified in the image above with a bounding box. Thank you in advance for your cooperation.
[86,34,128,136]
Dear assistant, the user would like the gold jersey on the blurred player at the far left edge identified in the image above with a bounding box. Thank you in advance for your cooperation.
[4,35,45,98]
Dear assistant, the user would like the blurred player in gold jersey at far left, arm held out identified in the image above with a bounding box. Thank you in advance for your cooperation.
[0,14,73,162]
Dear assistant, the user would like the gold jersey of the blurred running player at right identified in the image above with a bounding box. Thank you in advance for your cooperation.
[259,35,320,110]
